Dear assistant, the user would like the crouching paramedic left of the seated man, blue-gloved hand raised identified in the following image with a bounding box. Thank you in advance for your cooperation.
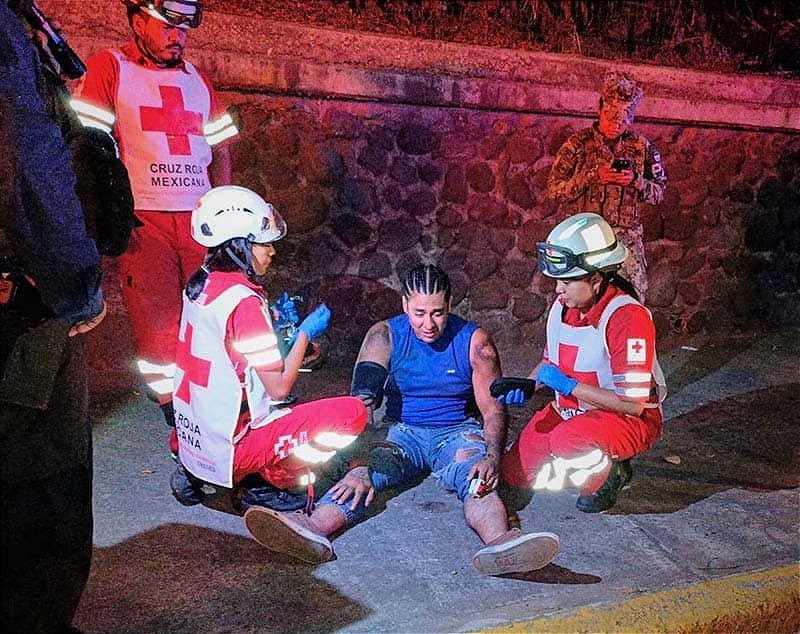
[171,185,367,520]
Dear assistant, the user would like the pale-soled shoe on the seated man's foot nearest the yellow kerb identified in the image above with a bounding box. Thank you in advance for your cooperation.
[472,528,561,575]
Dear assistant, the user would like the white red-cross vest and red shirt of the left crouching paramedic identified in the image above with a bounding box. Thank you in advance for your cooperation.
[173,273,291,487]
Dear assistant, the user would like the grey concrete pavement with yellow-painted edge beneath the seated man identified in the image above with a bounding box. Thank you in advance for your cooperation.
[75,330,800,633]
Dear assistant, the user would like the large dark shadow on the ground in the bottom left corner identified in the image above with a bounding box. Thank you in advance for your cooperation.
[75,524,370,634]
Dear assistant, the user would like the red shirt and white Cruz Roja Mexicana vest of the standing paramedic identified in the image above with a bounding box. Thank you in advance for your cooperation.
[72,43,237,211]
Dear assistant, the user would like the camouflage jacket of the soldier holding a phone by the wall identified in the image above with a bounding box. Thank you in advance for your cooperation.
[547,124,667,227]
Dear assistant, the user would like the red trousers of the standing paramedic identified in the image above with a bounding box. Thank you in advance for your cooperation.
[119,211,207,403]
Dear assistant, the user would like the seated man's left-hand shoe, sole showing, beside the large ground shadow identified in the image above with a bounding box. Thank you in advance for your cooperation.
[244,506,336,564]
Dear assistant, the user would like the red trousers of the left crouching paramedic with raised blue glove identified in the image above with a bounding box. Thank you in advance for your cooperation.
[233,396,367,489]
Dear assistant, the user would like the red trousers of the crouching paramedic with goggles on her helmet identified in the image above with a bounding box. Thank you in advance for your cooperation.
[500,403,662,495]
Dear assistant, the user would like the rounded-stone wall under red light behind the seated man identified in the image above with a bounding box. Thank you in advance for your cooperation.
[223,92,800,366]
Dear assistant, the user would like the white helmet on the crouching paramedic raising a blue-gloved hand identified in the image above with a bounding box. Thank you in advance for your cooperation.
[192,185,286,247]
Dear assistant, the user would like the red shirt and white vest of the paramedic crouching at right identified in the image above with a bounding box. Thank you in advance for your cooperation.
[545,288,663,419]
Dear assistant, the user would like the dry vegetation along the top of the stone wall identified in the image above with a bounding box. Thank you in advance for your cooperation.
[205,0,800,78]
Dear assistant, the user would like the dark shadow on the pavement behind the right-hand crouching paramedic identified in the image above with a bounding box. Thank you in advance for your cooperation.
[609,383,800,514]
